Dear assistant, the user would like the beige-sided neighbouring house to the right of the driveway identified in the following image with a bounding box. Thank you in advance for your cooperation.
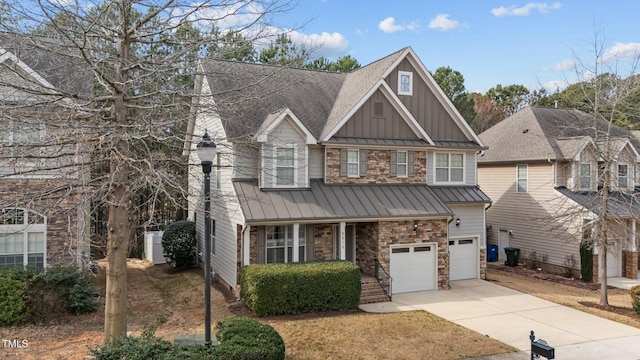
[478,107,640,280]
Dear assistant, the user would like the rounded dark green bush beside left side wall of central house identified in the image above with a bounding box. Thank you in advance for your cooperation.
[162,220,196,268]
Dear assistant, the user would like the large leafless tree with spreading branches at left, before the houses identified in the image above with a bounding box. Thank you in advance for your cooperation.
[0,0,294,341]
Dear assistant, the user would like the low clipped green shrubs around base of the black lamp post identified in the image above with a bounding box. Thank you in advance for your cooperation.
[91,317,285,360]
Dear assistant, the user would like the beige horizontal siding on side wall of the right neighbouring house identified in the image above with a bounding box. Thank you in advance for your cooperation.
[478,162,580,266]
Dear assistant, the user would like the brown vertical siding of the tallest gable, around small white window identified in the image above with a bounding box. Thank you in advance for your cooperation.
[385,58,469,141]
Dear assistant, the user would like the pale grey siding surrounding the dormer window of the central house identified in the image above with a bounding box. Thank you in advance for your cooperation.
[261,121,309,188]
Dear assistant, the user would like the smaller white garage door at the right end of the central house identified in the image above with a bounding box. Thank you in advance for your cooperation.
[449,239,479,281]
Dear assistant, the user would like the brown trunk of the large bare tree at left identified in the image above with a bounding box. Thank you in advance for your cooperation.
[104,0,132,343]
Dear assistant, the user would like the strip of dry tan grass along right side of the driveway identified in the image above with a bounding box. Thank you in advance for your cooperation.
[487,268,640,328]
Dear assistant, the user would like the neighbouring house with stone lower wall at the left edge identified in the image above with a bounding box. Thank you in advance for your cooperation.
[0,34,91,268]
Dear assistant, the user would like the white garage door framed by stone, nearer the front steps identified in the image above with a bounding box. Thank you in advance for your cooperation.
[390,244,437,294]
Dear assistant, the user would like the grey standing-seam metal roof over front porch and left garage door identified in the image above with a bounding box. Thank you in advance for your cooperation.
[233,181,453,223]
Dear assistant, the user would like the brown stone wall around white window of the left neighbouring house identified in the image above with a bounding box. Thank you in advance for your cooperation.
[0,179,89,267]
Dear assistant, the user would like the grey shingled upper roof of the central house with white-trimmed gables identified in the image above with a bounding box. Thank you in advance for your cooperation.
[200,47,484,148]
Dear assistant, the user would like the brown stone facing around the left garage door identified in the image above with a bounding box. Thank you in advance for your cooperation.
[378,219,449,289]
